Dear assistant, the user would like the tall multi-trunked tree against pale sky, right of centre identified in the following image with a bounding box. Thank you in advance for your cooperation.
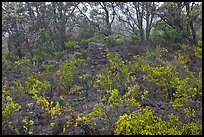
[117,2,156,41]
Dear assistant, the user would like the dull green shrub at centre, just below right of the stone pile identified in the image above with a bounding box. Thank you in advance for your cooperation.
[94,53,131,90]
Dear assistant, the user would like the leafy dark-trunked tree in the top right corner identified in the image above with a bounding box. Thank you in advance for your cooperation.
[157,2,198,45]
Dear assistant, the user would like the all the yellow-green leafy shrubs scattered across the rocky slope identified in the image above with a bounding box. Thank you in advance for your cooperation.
[2,36,202,135]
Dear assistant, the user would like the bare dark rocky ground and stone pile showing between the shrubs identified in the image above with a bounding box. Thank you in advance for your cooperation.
[2,43,202,135]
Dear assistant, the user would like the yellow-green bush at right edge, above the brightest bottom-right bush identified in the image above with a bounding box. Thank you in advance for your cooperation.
[141,55,202,108]
